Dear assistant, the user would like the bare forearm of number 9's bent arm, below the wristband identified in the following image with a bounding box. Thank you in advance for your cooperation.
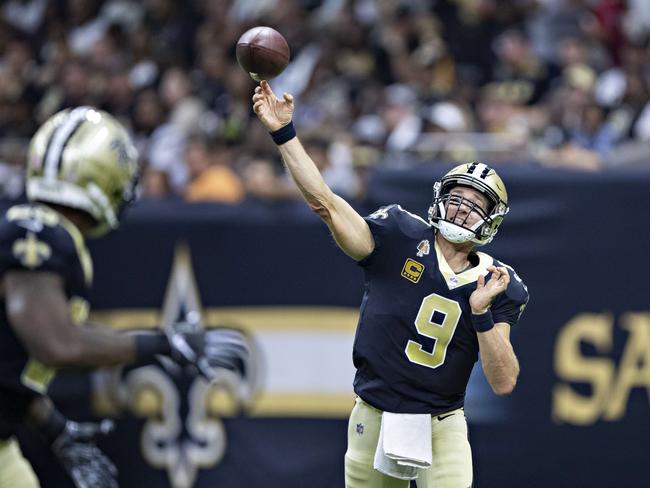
[476,325,519,395]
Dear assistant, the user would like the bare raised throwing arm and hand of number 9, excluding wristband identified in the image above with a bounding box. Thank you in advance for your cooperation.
[253,81,375,261]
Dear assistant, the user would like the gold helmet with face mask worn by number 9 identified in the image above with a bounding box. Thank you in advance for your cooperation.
[429,163,510,245]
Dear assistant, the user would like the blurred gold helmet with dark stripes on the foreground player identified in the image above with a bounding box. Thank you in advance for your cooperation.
[26,107,138,236]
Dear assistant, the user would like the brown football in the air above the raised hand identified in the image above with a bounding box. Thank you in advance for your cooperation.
[236,26,289,81]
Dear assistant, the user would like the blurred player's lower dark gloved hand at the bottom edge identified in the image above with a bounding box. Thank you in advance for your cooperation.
[51,420,118,488]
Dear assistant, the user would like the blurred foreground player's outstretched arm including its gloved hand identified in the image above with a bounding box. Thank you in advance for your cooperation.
[3,270,249,379]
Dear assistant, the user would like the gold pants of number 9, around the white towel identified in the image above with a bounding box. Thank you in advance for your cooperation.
[345,398,473,488]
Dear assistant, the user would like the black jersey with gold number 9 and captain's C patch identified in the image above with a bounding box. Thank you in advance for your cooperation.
[353,205,528,414]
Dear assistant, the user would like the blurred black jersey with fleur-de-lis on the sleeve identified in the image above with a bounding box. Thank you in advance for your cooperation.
[0,205,92,438]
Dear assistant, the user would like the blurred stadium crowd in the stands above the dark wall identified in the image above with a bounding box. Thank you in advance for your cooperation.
[0,0,650,203]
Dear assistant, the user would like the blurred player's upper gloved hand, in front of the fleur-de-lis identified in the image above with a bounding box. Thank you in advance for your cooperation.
[167,322,251,381]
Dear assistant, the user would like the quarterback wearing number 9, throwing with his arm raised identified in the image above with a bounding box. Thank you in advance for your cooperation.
[253,81,528,488]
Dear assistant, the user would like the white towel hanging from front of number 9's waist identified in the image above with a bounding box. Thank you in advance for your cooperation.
[374,412,431,480]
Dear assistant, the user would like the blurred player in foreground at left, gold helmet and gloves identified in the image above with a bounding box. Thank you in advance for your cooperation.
[0,107,246,488]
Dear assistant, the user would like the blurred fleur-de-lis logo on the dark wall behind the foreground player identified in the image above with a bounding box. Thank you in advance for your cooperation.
[94,246,261,488]
